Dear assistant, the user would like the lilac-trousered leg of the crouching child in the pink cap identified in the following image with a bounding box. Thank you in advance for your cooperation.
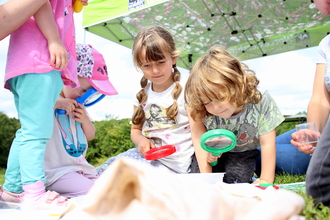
[47,172,97,197]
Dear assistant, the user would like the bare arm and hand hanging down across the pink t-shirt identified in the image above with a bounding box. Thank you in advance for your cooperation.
[34,2,68,69]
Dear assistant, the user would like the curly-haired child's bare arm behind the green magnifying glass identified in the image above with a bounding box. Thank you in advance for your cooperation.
[186,107,212,173]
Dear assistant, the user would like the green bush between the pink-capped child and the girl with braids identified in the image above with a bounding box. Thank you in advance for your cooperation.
[86,118,134,164]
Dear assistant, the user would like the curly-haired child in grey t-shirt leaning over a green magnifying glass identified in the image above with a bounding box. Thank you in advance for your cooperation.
[185,46,284,183]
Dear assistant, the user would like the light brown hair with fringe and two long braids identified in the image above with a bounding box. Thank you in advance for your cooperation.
[132,27,182,126]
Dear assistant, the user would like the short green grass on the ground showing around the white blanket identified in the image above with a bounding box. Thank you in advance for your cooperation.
[0,168,330,220]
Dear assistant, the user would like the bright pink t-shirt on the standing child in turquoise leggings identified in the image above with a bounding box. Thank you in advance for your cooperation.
[5,0,79,89]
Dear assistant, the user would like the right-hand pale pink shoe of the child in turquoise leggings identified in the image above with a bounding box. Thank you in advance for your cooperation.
[22,191,72,212]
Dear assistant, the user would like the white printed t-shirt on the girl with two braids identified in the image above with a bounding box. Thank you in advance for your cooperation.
[133,76,194,173]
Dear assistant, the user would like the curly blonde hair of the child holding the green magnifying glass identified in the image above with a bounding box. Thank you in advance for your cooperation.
[184,46,262,120]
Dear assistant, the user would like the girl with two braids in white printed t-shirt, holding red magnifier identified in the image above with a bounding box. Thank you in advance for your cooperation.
[97,27,194,174]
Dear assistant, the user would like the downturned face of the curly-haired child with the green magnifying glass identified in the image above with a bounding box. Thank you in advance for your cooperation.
[203,100,238,118]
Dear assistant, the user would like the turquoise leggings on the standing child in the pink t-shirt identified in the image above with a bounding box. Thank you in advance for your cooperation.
[4,71,63,203]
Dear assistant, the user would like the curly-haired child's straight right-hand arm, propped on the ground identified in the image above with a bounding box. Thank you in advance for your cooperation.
[254,129,276,184]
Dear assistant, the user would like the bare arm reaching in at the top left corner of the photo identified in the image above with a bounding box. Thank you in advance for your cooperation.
[0,0,47,40]
